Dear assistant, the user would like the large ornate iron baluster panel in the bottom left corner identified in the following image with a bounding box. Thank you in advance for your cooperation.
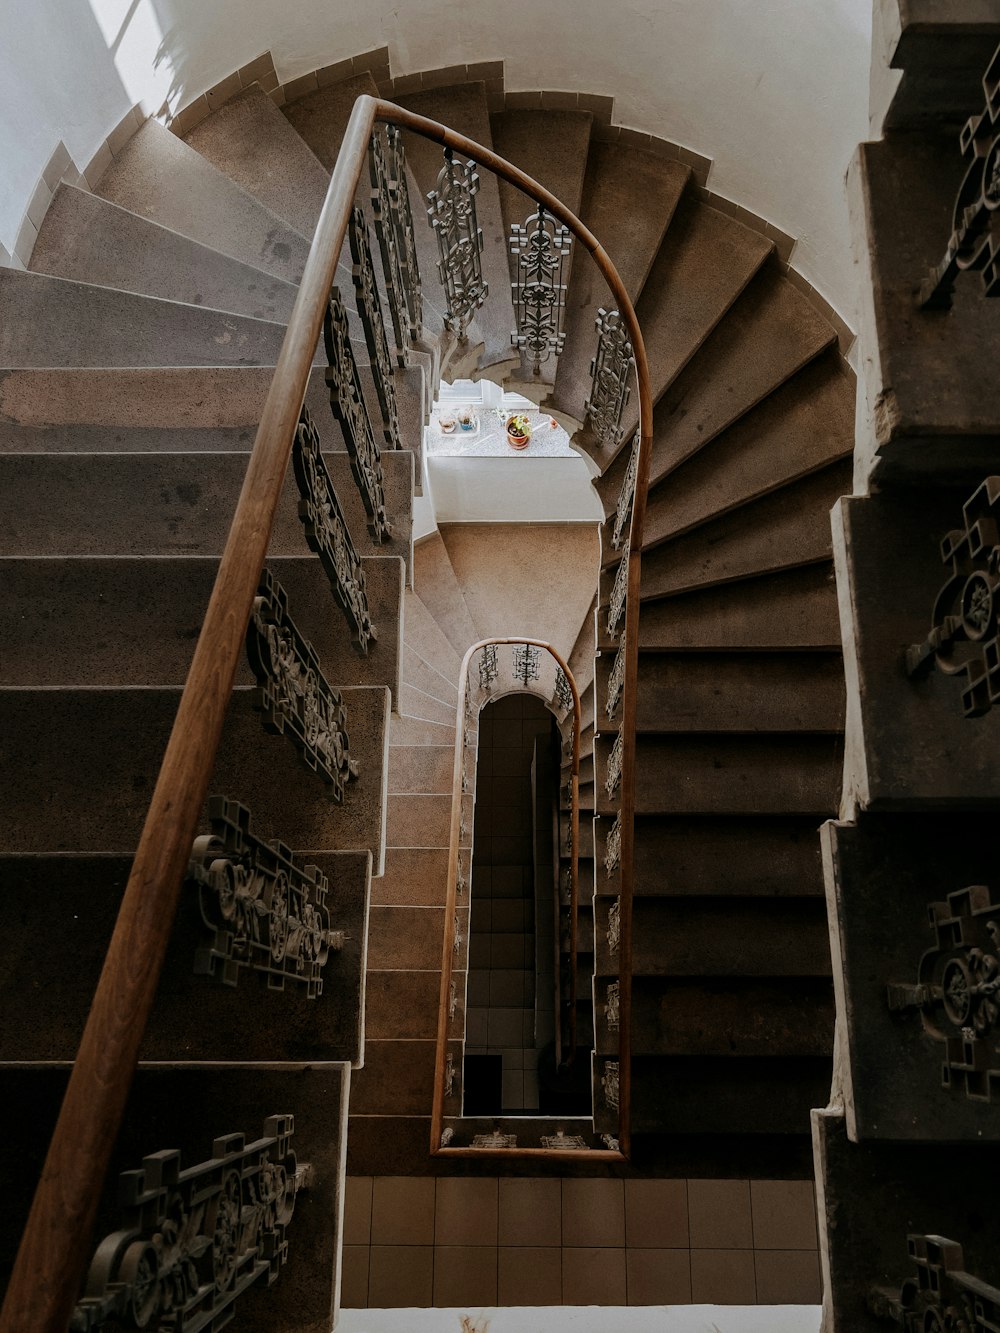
[69,1116,309,1333]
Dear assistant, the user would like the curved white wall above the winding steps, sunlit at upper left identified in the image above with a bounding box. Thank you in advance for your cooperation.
[0,0,871,324]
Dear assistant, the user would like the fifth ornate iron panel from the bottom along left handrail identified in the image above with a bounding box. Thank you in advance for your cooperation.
[323,287,392,544]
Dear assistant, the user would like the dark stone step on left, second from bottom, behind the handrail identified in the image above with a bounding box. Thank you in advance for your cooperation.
[0,853,371,1064]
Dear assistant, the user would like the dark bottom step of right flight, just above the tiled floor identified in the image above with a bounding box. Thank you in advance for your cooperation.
[632,1056,831,1135]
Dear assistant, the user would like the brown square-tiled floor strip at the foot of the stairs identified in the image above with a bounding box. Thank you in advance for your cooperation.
[341,1176,820,1309]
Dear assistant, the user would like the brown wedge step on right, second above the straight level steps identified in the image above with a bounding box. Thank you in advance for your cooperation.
[641,459,852,601]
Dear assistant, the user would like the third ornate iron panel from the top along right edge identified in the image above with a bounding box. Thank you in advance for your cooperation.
[887,884,1000,1101]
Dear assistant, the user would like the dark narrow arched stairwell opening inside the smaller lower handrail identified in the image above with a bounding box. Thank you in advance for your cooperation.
[463,692,591,1117]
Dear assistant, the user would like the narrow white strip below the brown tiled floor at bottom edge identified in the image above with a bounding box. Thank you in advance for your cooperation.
[337,1305,821,1333]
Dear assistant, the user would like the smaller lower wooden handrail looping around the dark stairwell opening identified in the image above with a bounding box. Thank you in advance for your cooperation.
[431,635,600,1158]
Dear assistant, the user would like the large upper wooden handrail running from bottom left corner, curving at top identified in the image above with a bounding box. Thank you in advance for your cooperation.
[0,95,652,1333]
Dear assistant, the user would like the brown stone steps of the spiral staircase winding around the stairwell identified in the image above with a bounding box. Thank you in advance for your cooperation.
[0,46,853,1330]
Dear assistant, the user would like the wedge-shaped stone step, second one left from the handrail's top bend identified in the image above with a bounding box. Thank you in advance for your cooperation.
[184,87,329,237]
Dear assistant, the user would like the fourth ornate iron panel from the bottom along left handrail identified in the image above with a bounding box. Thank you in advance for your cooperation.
[292,407,379,653]
